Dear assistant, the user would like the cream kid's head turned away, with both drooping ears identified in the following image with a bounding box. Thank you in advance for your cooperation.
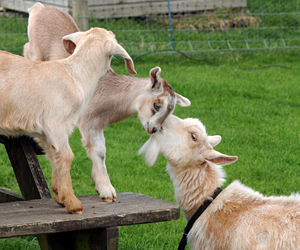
[63,28,136,75]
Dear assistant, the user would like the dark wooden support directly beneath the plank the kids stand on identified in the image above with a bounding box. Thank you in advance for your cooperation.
[38,227,119,250]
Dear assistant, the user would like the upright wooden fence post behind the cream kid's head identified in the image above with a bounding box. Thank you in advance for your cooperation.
[72,0,89,31]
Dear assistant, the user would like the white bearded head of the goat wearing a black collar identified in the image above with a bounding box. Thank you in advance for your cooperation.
[139,115,237,169]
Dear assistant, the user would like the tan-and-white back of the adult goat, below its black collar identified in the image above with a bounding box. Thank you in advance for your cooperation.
[188,181,300,250]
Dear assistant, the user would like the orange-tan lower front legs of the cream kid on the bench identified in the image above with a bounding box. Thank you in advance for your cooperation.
[46,139,83,214]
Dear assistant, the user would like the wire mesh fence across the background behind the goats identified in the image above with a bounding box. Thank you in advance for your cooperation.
[0,0,300,55]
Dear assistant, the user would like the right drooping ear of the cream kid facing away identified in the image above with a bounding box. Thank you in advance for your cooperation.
[105,40,136,75]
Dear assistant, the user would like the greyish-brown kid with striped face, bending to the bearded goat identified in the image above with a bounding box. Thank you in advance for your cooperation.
[24,3,190,201]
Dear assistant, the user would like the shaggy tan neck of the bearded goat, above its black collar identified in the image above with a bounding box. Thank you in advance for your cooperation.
[167,163,225,220]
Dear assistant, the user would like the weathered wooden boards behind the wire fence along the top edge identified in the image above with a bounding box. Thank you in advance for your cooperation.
[2,0,247,18]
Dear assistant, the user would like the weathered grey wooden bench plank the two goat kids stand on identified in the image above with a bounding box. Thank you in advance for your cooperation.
[0,193,180,238]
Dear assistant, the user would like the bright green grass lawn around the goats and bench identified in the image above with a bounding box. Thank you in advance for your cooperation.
[0,50,300,250]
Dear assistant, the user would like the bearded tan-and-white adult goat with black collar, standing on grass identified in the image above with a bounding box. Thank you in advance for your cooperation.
[139,116,300,250]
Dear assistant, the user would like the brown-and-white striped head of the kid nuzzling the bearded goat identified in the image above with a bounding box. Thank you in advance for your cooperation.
[138,67,191,134]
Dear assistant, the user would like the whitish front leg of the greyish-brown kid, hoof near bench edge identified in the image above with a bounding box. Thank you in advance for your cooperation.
[80,128,117,202]
